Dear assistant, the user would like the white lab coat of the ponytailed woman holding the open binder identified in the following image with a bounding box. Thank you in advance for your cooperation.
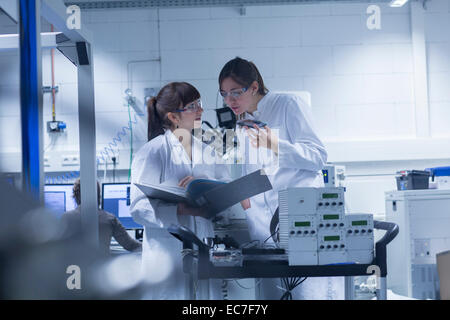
[130,130,229,300]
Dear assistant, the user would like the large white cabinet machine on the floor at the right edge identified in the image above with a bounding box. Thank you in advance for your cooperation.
[385,189,450,299]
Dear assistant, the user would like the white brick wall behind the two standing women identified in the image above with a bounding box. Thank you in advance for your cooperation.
[0,0,450,216]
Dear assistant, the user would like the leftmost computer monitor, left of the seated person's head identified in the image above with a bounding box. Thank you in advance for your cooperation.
[44,184,77,215]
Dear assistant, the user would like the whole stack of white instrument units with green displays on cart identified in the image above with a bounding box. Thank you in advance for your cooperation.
[279,187,374,265]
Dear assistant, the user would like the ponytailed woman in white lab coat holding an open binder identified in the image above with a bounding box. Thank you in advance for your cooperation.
[130,82,229,299]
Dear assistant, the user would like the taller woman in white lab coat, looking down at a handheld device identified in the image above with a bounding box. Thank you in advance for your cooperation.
[219,57,343,299]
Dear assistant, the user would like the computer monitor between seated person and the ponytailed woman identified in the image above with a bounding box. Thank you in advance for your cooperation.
[102,183,143,229]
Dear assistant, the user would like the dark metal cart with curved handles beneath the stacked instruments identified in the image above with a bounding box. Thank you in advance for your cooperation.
[168,221,399,300]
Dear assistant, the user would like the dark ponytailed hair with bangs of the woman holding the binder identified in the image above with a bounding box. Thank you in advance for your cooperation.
[147,82,200,141]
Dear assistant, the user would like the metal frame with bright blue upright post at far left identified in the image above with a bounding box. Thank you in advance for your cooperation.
[19,0,98,246]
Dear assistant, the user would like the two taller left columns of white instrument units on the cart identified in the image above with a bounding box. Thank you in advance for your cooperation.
[279,187,346,265]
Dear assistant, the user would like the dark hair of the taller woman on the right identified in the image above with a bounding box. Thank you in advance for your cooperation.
[219,57,269,96]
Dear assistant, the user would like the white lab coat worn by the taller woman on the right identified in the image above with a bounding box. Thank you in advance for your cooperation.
[237,92,343,299]
